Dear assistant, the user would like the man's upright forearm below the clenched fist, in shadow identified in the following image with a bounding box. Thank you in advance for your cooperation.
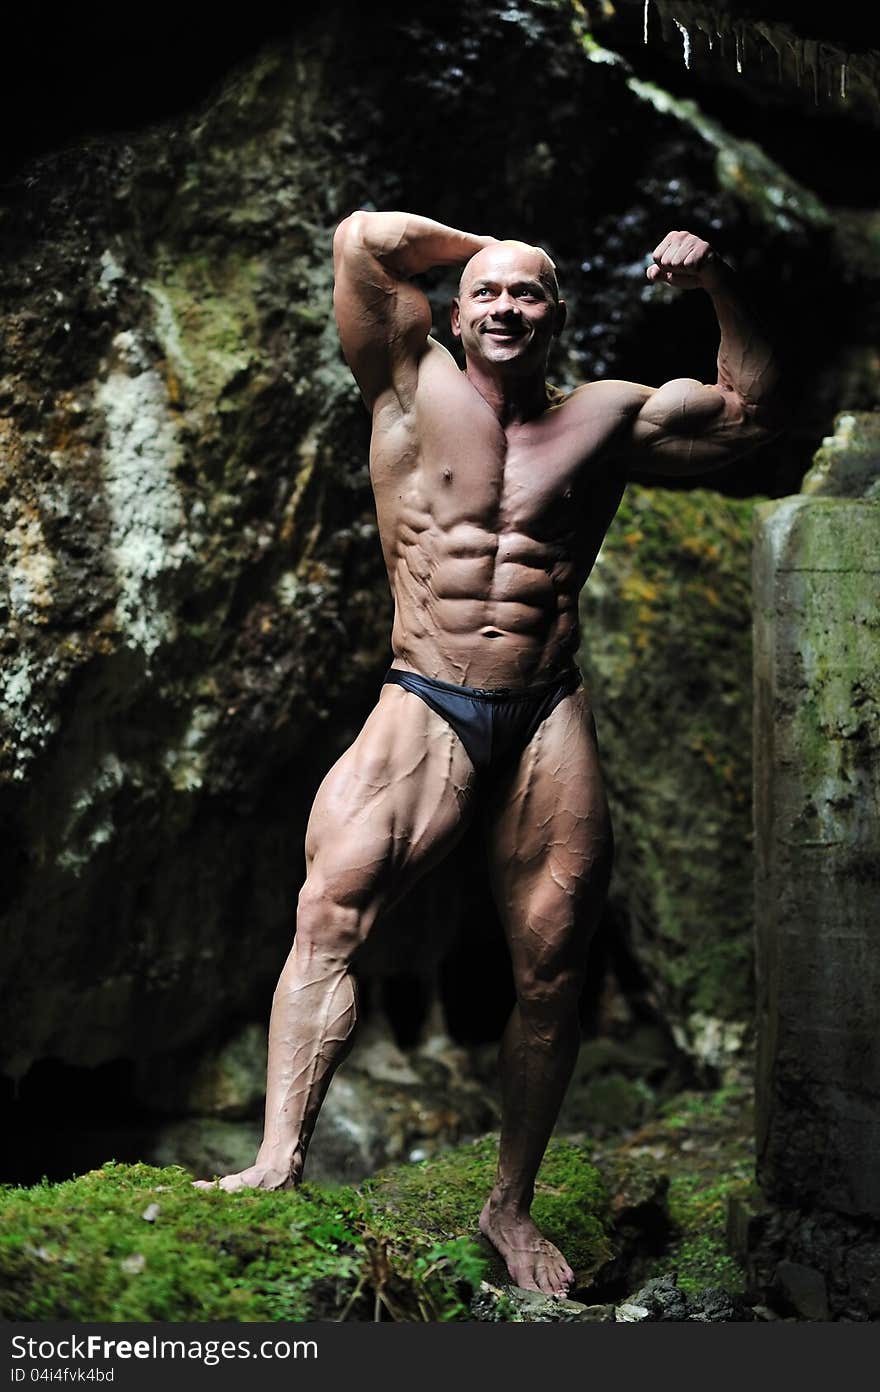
[706,263,780,418]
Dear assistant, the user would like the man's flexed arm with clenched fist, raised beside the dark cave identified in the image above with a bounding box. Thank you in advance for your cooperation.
[621,231,780,476]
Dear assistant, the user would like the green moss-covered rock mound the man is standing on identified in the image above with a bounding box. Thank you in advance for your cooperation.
[0,1137,608,1322]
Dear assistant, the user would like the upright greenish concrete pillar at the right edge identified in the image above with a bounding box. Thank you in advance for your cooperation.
[753,494,880,1218]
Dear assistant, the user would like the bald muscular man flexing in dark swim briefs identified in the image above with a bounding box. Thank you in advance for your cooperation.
[196,212,774,1295]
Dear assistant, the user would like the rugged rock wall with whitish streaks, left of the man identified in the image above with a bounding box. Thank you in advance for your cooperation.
[0,29,388,1073]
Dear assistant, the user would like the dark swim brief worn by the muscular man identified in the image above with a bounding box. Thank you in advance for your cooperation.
[386,667,581,771]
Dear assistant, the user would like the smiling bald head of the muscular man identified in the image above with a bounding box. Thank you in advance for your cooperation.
[451,241,565,374]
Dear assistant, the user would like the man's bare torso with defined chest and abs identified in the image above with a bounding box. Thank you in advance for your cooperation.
[370,342,625,686]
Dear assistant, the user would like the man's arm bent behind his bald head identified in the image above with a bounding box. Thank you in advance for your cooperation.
[333,212,496,409]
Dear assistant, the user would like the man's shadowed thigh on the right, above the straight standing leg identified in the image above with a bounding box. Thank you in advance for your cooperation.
[483,690,614,973]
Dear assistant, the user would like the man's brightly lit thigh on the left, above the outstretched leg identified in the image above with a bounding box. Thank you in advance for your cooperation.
[305,685,475,902]
